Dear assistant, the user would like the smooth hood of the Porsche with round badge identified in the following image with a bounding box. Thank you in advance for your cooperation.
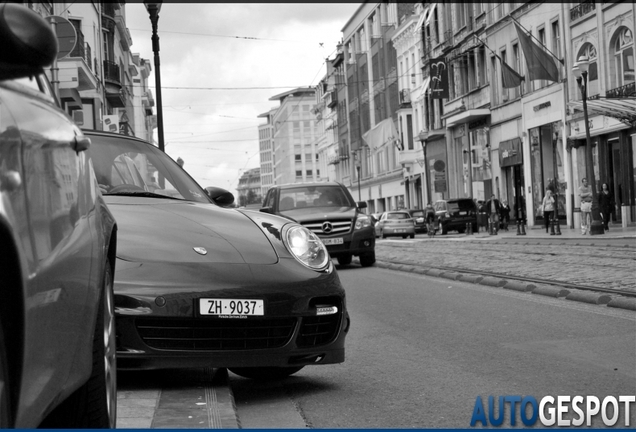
[104,196,278,264]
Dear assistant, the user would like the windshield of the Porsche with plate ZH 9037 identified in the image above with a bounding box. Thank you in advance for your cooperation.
[87,133,210,203]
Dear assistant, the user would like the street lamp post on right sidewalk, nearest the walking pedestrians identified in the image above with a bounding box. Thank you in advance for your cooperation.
[572,56,605,235]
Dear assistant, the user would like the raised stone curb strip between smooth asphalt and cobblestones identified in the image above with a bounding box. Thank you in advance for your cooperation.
[376,261,636,311]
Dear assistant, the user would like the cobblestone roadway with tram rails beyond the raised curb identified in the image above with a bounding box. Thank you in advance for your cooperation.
[376,226,636,292]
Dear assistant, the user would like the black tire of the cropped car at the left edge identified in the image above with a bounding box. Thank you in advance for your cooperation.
[41,261,117,429]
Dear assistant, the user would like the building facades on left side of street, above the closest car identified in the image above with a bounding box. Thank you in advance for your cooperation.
[34,2,156,142]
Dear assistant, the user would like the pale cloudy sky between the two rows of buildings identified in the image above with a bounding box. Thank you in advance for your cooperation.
[126,2,360,194]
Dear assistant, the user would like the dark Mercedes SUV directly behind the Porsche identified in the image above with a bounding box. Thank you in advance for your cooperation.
[261,182,375,267]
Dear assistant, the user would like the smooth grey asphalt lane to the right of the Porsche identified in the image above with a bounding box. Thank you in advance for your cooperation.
[230,267,636,428]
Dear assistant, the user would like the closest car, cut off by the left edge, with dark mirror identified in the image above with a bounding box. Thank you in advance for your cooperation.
[0,3,117,429]
